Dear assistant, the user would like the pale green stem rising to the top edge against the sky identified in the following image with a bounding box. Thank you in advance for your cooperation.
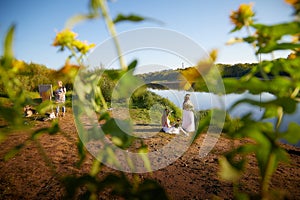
[99,0,127,70]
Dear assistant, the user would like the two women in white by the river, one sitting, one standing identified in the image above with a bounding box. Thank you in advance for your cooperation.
[161,94,195,135]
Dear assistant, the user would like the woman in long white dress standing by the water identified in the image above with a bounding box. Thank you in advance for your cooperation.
[182,94,195,132]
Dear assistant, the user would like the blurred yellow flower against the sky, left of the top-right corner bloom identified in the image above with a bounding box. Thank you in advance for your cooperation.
[230,3,255,31]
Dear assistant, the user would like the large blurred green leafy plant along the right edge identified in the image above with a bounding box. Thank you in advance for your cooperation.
[220,1,300,199]
